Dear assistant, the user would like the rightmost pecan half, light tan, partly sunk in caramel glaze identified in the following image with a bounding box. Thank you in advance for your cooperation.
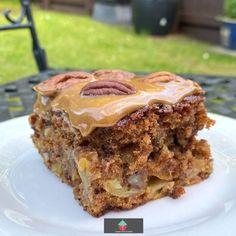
[144,71,185,84]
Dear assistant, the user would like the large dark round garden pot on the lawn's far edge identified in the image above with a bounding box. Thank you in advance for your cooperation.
[132,0,178,35]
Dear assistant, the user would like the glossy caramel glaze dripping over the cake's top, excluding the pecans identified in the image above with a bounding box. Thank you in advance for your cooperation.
[34,74,202,136]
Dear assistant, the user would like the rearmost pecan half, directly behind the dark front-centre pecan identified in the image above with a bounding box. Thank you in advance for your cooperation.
[93,70,135,80]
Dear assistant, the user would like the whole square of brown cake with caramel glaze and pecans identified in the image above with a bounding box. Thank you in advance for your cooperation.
[29,70,214,216]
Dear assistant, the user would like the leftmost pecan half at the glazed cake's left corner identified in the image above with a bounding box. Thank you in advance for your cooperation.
[33,71,94,96]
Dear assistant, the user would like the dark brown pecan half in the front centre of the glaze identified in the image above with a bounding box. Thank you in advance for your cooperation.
[80,80,136,96]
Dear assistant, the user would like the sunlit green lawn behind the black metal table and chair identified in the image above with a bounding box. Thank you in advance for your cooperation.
[0,0,236,83]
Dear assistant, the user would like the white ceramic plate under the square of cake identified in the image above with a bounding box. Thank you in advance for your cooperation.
[0,114,236,236]
